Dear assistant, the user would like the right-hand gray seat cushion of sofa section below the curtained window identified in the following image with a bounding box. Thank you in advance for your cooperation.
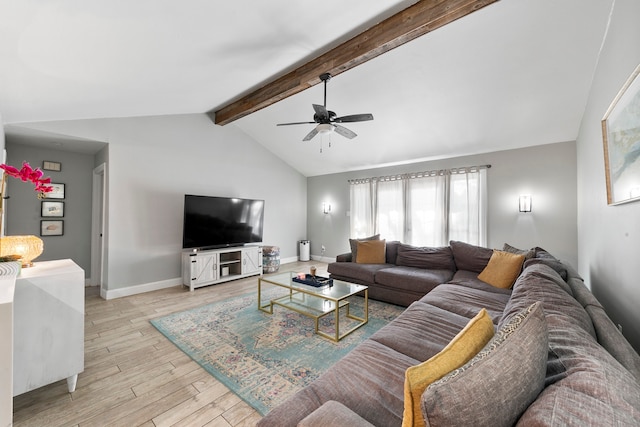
[375,266,453,294]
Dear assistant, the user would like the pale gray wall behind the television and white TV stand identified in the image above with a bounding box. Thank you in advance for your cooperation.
[16,114,306,291]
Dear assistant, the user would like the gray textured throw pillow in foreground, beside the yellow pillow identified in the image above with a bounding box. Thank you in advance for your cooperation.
[422,303,548,426]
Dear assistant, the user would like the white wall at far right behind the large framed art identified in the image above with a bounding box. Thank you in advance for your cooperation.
[577,0,640,350]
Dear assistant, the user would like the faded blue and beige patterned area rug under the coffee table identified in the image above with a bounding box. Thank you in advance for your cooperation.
[151,294,405,415]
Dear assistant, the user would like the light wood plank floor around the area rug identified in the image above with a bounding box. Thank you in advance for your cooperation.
[13,261,326,427]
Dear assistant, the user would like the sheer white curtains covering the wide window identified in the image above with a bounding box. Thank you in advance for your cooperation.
[350,167,487,246]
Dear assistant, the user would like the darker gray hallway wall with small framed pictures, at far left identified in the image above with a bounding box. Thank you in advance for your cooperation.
[5,141,94,277]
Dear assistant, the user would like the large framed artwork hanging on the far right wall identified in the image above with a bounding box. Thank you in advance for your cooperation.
[602,65,640,205]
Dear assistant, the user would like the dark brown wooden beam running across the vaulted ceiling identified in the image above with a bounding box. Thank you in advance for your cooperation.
[214,0,498,125]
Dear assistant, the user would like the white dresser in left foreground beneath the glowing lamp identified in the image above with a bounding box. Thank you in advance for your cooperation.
[13,259,84,396]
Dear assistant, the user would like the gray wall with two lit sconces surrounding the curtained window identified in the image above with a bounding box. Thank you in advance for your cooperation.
[307,142,577,267]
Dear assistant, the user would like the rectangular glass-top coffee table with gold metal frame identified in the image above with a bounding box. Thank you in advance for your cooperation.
[258,272,369,341]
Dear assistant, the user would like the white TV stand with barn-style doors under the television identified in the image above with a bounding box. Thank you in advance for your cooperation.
[182,246,262,291]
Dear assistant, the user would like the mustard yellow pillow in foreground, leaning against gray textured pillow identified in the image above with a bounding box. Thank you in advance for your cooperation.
[402,308,494,427]
